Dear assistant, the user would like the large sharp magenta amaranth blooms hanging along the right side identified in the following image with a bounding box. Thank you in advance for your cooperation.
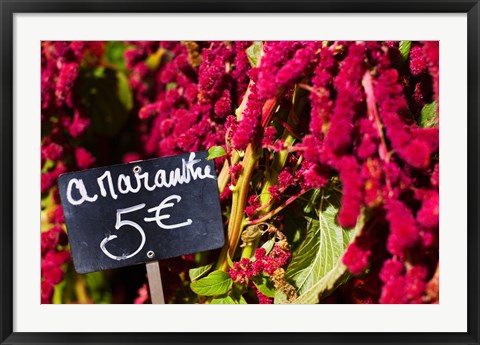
[303,42,439,303]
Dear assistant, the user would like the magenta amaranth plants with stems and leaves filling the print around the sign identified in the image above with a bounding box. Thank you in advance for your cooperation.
[41,41,439,303]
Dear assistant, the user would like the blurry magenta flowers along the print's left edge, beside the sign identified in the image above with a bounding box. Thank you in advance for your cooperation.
[41,42,104,303]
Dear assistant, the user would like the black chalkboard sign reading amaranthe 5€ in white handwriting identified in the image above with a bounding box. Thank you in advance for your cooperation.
[58,151,225,273]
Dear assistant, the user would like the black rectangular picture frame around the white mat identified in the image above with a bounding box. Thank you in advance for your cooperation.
[0,0,480,344]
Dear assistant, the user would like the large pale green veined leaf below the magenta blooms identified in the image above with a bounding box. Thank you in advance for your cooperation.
[286,191,363,303]
